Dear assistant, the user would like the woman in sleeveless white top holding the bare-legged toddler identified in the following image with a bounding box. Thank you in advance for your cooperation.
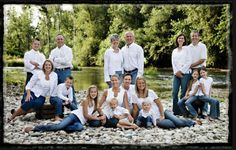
[99,75,133,127]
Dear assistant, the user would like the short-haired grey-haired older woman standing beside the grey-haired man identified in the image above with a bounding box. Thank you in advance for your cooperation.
[104,34,124,88]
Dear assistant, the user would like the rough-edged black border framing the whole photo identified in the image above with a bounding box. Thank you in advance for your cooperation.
[0,0,236,150]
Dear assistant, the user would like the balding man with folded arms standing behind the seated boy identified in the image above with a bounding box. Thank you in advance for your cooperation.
[49,34,77,110]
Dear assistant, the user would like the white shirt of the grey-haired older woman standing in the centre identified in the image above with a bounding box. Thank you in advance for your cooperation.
[104,48,124,82]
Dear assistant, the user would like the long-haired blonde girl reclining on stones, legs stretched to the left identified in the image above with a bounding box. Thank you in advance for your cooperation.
[25,85,106,133]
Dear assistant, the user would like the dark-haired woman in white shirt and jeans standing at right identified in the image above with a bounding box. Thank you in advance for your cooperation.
[171,34,192,115]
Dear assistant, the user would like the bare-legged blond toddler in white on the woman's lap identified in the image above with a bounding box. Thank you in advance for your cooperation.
[107,98,138,129]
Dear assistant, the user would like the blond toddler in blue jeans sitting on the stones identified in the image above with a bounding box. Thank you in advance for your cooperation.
[136,98,156,128]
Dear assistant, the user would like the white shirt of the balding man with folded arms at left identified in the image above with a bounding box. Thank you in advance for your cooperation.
[49,44,73,69]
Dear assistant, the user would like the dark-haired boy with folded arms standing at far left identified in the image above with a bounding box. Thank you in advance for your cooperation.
[24,38,45,86]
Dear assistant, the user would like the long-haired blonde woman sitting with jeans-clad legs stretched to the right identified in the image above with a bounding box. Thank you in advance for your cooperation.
[132,76,201,129]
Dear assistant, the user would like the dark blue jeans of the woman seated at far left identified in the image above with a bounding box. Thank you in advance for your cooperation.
[21,91,45,112]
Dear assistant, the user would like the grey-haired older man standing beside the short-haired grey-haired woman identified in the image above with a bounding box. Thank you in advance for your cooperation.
[121,31,144,84]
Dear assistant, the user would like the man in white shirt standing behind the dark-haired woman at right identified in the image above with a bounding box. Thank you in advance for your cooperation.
[189,31,207,69]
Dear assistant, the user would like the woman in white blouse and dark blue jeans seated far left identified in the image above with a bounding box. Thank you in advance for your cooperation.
[8,60,57,122]
